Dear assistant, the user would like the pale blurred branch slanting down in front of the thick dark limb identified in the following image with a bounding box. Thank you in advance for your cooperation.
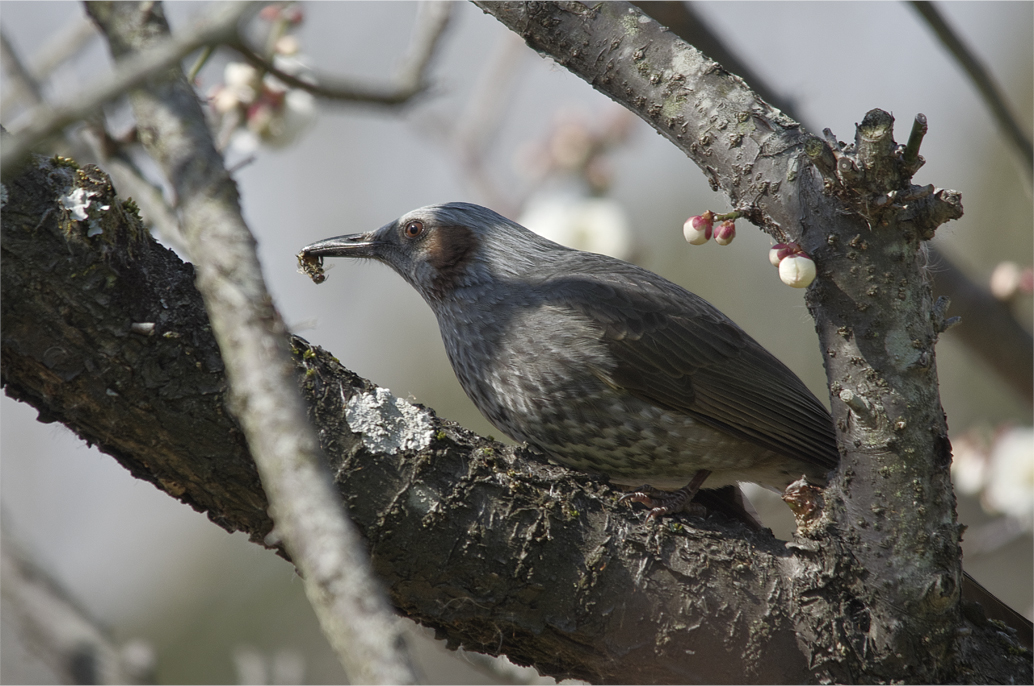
[82,2,416,684]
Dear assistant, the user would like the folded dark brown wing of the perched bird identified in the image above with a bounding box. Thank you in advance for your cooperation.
[548,263,839,469]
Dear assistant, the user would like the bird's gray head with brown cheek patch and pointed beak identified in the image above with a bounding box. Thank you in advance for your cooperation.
[299,203,567,306]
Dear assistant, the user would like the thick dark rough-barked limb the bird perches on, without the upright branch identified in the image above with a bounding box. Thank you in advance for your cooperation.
[0,153,1030,683]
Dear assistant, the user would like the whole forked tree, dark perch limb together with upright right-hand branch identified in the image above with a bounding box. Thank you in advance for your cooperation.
[0,3,1032,683]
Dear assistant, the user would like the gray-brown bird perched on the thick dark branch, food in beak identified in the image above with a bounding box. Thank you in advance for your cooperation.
[298,203,839,518]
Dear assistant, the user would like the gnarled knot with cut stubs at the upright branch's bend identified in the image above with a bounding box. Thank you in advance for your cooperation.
[804,110,963,240]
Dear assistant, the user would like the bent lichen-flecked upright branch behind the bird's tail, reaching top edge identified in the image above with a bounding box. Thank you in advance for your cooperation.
[477,2,1025,681]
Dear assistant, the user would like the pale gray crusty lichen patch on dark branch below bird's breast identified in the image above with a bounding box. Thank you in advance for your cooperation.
[344,388,434,454]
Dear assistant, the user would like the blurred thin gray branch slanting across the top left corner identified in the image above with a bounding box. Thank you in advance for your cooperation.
[0,2,253,175]
